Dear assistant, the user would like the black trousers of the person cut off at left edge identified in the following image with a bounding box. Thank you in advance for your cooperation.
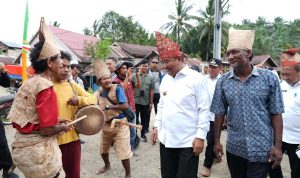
[0,119,13,171]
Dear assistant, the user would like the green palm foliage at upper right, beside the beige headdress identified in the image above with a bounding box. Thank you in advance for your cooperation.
[234,17,300,64]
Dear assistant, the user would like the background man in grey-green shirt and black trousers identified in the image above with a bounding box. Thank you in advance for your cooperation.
[133,60,154,142]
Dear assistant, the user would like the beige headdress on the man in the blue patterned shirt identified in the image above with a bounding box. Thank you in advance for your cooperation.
[227,28,255,51]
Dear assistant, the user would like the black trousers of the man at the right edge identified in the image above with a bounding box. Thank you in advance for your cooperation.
[269,142,300,178]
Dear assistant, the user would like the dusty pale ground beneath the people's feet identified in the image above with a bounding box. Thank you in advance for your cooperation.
[1,112,290,178]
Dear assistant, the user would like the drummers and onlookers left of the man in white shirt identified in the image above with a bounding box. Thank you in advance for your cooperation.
[5,18,161,178]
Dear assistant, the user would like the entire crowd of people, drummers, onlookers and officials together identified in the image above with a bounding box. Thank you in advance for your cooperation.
[1,18,300,178]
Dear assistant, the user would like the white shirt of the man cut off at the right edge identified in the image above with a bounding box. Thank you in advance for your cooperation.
[280,80,300,144]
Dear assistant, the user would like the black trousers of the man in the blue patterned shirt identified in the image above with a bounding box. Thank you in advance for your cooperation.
[226,151,268,178]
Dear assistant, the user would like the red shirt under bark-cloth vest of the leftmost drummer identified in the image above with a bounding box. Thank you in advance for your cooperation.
[12,87,58,133]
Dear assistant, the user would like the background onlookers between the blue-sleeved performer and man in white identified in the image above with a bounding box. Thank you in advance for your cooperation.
[106,54,164,146]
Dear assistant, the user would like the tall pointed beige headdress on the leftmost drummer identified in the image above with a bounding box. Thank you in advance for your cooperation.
[39,17,60,60]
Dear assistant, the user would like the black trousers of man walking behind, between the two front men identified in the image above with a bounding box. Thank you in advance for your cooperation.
[203,121,215,169]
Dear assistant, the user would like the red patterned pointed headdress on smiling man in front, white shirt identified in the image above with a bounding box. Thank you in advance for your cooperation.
[155,32,182,59]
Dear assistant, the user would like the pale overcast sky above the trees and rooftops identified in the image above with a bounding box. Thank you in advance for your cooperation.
[0,0,300,44]
